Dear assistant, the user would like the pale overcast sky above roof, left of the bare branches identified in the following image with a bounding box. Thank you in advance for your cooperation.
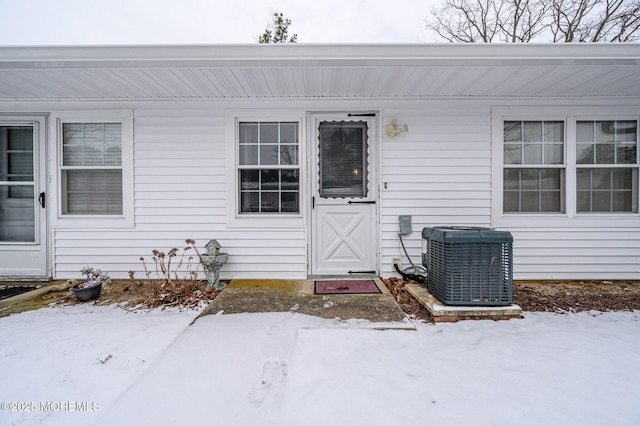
[0,0,441,45]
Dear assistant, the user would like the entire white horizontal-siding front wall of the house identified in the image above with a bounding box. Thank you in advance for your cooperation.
[0,99,640,279]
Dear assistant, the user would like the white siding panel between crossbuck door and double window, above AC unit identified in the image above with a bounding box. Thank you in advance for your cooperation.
[380,100,491,275]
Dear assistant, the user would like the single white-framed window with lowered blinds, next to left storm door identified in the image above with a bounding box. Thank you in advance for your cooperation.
[53,111,133,227]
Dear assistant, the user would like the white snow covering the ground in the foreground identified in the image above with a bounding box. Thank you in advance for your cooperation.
[0,305,640,426]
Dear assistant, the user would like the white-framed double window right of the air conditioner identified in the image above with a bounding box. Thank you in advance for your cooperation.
[494,108,639,218]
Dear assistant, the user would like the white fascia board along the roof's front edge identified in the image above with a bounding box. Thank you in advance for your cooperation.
[0,43,640,69]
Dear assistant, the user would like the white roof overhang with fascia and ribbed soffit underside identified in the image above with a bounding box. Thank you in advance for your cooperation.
[0,43,640,101]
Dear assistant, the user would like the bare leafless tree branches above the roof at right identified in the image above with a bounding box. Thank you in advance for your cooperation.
[425,0,640,43]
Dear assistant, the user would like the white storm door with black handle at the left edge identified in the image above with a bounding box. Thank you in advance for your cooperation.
[0,118,48,278]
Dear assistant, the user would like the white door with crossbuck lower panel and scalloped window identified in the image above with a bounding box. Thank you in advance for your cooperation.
[310,114,379,277]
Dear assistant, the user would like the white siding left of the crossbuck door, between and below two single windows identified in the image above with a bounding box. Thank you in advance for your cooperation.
[54,101,307,279]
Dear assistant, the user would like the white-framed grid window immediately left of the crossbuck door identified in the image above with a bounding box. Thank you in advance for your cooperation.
[237,121,300,215]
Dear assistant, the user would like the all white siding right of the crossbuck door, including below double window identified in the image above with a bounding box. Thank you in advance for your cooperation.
[380,100,640,280]
